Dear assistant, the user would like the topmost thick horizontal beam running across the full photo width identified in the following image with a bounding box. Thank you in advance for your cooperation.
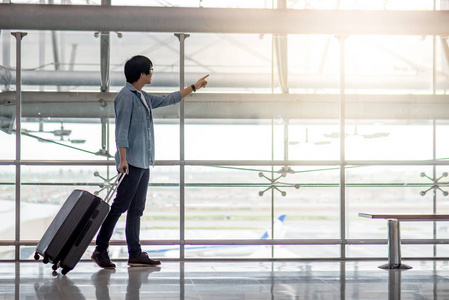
[0,4,449,36]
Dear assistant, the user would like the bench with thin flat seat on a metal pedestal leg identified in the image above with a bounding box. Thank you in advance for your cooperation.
[359,213,449,269]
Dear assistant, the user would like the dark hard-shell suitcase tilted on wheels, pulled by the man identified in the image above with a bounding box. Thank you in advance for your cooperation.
[34,173,125,275]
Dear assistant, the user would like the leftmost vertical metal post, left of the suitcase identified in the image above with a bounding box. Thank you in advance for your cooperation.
[11,32,27,261]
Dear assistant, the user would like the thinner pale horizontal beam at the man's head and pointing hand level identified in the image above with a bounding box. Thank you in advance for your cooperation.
[0,71,442,92]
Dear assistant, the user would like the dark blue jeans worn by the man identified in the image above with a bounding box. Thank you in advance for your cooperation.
[96,165,150,257]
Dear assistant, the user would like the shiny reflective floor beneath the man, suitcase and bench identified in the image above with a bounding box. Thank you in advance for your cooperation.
[0,261,449,300]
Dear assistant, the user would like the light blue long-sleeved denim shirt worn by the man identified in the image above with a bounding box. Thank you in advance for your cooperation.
[114,82,182,169]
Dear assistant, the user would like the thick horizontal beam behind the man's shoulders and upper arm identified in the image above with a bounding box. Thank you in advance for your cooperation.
[0,92,449,120]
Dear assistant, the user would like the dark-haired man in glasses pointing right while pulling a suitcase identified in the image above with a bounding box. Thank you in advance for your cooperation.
[92,55,209,269]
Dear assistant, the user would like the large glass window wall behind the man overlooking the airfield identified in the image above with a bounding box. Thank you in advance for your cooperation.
[0,7,449,258]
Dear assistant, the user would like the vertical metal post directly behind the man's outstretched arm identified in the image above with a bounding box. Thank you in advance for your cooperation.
[175,33,190,260]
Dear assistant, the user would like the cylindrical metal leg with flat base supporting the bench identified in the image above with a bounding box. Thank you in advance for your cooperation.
[379,220,412,269]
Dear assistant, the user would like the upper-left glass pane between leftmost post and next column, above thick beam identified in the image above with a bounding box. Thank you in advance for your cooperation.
[16,31,100,91]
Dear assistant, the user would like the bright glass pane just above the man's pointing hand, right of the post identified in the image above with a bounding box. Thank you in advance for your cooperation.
[185,34,272,93]
